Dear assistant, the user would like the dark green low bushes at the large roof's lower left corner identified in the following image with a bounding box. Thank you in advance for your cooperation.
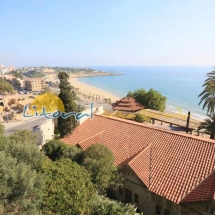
[42,140,83,163]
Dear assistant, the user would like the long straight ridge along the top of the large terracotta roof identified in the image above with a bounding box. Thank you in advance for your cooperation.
[94,114,215,144]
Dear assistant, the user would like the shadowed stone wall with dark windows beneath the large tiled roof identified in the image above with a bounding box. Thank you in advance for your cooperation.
[115,167,215,215]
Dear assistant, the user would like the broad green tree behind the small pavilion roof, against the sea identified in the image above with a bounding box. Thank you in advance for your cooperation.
[127,88,167,111]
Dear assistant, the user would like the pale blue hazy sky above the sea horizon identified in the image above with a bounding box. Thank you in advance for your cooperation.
[0,0,215,67]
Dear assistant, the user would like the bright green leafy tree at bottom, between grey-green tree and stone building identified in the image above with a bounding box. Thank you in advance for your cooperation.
[42,158,95,215]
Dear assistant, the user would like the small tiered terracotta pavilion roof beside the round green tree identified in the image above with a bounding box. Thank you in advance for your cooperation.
[112,97,145,112]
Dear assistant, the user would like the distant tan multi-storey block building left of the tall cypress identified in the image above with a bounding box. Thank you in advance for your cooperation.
[24,78,45,91]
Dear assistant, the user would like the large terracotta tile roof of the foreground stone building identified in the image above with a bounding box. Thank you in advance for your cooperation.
[62,115,215,203]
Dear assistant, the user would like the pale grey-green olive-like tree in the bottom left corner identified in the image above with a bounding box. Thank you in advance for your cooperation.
[0,135,45,215]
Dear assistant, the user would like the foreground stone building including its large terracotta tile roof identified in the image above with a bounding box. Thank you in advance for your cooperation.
[62,115,215,215]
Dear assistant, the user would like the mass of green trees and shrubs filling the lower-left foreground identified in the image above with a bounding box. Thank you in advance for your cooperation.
[0,130,143,215]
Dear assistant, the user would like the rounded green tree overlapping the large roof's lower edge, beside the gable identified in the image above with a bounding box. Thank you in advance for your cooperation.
[82,144,122,194]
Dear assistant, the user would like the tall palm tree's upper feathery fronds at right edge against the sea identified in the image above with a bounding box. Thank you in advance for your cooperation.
[199,67,215,116]
